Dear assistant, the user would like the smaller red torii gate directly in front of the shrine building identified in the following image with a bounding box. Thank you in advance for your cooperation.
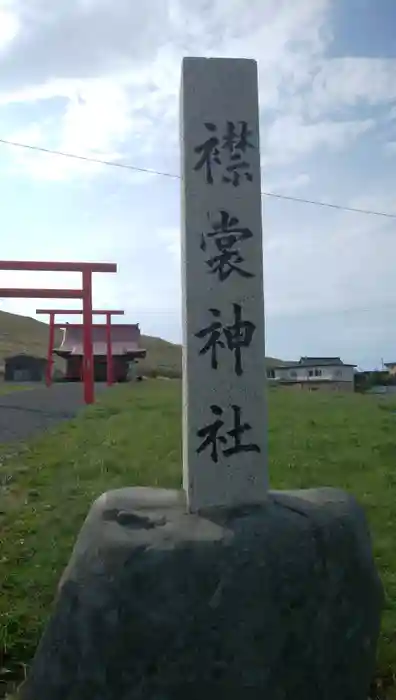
[36,309,124,386]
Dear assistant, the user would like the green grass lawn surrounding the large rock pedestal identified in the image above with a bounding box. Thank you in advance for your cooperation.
[0,380,396,699]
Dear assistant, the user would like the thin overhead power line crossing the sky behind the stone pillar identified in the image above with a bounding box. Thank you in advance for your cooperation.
[0,138,396,219]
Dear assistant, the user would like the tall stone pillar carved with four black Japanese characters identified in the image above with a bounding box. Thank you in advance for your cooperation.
[181,58,267,511]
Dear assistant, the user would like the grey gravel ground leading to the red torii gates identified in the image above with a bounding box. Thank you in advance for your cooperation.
[0,383,106,443]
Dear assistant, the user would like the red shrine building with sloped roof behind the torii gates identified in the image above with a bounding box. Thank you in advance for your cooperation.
[54,323,146,382]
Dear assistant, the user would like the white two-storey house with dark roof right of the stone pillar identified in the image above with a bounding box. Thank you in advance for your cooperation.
[267,357,356,391]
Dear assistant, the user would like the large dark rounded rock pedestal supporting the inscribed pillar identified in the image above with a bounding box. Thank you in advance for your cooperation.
[21,488,382,700]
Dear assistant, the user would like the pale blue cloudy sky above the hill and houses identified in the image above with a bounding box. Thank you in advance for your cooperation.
[0,0,396,369]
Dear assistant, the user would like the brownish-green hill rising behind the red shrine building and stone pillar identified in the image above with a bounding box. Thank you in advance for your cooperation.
[0,311,280,376]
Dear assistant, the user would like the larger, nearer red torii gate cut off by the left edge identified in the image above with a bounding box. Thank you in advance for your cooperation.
[0,260,117,404]
